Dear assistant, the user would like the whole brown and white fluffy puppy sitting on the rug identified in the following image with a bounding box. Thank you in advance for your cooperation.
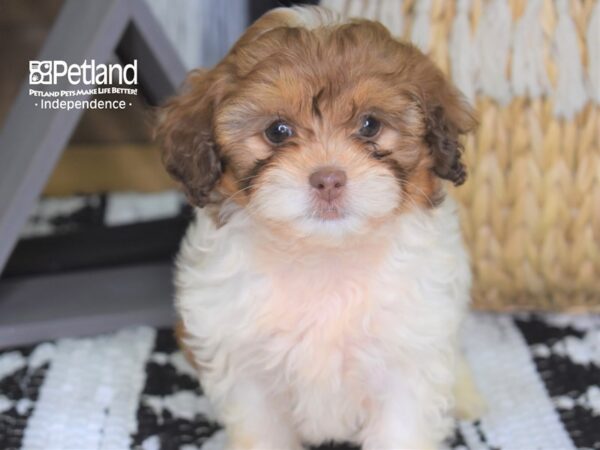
[157,7,478,450]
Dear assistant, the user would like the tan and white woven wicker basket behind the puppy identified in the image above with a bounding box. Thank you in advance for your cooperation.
[321,0,600,311]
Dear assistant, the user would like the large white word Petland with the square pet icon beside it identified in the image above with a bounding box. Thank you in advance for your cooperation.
[29,59,137,86]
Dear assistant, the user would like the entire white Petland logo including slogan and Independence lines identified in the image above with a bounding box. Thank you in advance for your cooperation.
[29,59,138,111]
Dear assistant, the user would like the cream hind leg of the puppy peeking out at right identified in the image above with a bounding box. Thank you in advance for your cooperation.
[454,354,486,420]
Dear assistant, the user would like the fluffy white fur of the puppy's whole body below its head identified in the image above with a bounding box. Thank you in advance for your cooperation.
[176,199,470,450]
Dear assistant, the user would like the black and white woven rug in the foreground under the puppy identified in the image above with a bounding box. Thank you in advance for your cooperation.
[0,314,600,450]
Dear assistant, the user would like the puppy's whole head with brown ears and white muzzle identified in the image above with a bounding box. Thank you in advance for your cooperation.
[157,8,474,236]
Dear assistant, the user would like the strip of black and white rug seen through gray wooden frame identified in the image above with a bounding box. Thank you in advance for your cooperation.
[0,190,192,278]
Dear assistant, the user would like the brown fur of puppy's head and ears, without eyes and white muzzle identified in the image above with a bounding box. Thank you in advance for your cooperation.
[157,9,475,211]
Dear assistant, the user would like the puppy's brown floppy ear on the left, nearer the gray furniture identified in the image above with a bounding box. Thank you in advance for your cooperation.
[155,70,223,207]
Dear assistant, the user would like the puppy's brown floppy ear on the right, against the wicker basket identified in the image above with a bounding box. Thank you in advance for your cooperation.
[414,68,477,186]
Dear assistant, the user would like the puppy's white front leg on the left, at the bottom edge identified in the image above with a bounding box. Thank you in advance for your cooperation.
[220,380,303,450]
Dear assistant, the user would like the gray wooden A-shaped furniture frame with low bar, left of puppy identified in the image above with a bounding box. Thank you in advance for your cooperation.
[0,0,185,347]
